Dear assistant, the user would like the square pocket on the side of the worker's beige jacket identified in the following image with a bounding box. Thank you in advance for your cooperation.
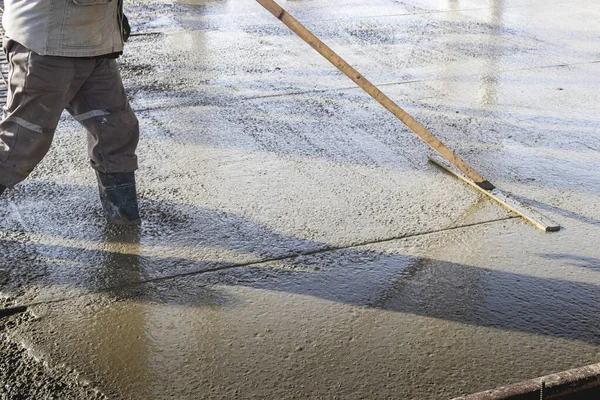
[61,0,112,47]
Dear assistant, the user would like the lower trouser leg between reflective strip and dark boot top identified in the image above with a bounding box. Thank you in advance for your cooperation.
[76,109,140,173]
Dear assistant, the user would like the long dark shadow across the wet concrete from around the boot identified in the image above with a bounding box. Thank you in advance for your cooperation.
[0,182,600,344]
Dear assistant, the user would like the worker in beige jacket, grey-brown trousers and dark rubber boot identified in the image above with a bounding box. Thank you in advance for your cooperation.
[0,0,139,223]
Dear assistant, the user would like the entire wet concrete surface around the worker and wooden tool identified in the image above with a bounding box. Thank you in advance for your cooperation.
[0,0,600,399]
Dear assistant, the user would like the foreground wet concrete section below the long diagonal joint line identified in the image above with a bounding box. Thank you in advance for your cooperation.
[11,220,600,399]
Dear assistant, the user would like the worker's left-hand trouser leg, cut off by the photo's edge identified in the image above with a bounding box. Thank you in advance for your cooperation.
[0,41,84,187]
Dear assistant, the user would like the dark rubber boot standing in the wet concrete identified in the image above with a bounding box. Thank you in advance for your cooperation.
[96,171,140,225]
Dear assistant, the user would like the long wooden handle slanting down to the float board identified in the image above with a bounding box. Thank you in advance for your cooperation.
[256,0,494,190]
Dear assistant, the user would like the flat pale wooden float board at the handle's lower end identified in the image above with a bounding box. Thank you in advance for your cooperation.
[429,157,560,232]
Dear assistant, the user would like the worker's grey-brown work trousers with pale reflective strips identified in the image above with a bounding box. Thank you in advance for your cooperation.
[0,40,139,187]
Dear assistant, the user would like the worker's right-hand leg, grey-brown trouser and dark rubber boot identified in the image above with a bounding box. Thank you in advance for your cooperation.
[67,59,139,223]
